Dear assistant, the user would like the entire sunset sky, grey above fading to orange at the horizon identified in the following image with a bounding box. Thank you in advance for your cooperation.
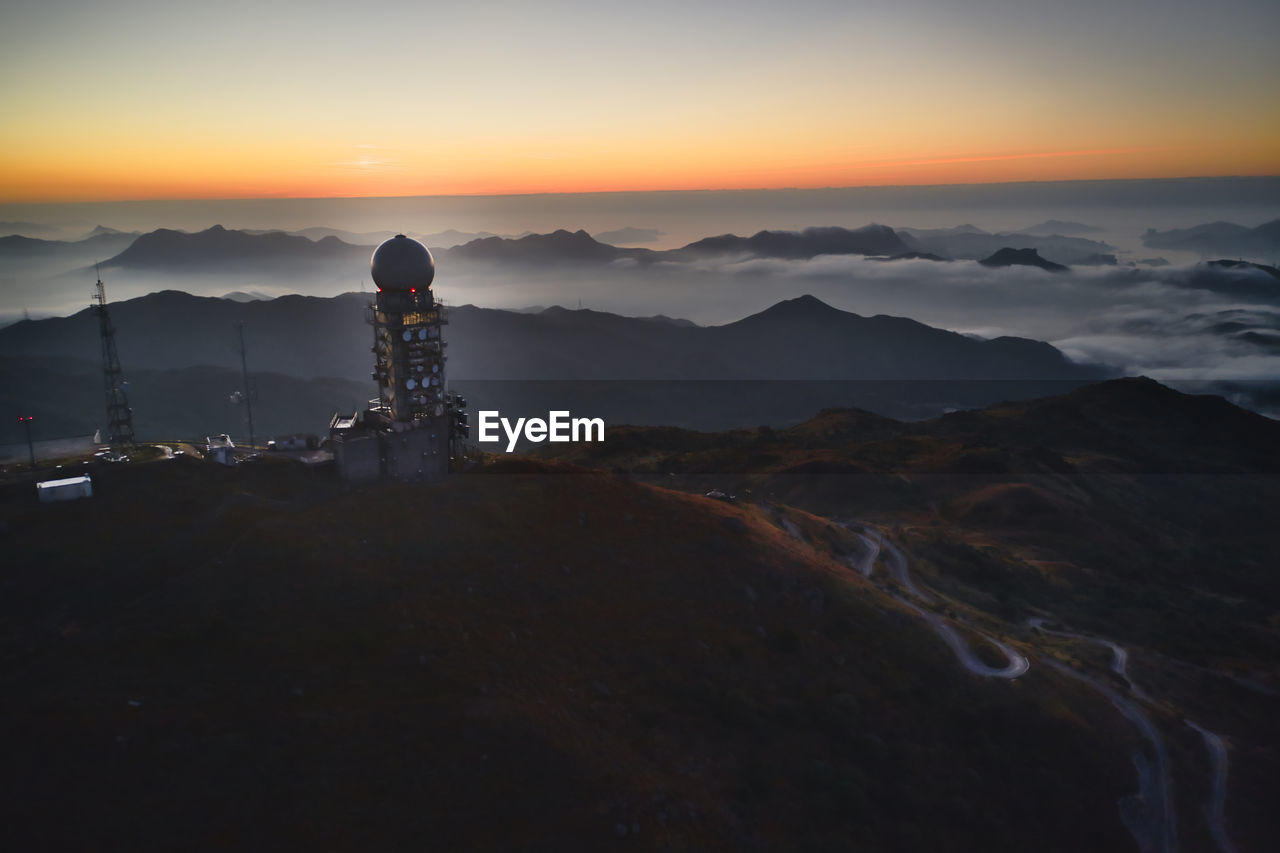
[0,0,1280,202]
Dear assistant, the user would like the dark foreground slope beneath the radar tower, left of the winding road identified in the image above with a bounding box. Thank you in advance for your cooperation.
[0,460,1133,850]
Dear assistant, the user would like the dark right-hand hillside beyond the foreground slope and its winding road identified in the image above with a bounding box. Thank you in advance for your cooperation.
[541,379,1280,849]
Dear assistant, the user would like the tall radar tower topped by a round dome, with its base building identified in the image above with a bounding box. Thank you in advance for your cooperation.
[329,234,467,482]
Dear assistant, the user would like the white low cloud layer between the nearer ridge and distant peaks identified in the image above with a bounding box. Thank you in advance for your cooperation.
[9,239,1280,412]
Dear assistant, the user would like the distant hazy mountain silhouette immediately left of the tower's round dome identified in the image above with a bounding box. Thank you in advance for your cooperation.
[102,225,369,270]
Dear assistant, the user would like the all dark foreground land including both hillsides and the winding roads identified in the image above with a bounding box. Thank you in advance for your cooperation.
[0,383,1280,850]
